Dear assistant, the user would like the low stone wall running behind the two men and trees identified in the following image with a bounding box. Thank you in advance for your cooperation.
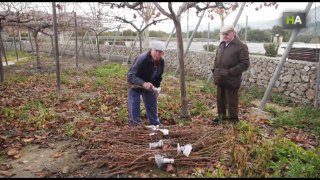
[5,43,320,104]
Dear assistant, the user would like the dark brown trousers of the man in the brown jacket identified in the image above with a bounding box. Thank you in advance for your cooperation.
[217,86,239,120]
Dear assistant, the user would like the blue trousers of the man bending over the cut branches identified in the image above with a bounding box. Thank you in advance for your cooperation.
[128,88,160,125]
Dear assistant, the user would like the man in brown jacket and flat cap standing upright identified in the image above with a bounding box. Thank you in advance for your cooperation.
[211,25,250,124]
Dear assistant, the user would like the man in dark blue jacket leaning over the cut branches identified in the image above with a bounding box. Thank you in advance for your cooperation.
[127,41,165,126]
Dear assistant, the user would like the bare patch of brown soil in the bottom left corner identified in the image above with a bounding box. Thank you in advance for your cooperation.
[2,141,79,178]
